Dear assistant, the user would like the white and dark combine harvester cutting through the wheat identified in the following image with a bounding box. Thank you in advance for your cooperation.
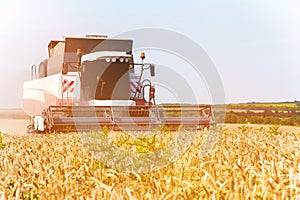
[23,36,215,133]
